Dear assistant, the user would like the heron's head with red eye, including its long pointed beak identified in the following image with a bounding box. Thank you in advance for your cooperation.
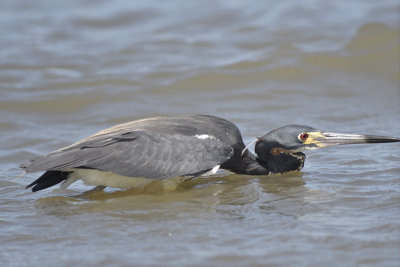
[248,125,400,176]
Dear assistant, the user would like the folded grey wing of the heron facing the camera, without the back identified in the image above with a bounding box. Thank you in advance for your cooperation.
[21,131,233,179]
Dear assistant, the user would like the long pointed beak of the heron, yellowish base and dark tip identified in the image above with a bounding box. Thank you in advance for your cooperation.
[313,132,400,147]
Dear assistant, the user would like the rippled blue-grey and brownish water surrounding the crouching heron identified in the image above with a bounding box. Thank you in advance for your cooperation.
[0,0,400,266]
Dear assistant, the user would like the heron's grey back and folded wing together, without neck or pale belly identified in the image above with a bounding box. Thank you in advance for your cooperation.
[21,115,250,186]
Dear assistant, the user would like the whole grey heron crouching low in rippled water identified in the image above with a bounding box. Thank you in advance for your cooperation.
[20,115,400,191]
